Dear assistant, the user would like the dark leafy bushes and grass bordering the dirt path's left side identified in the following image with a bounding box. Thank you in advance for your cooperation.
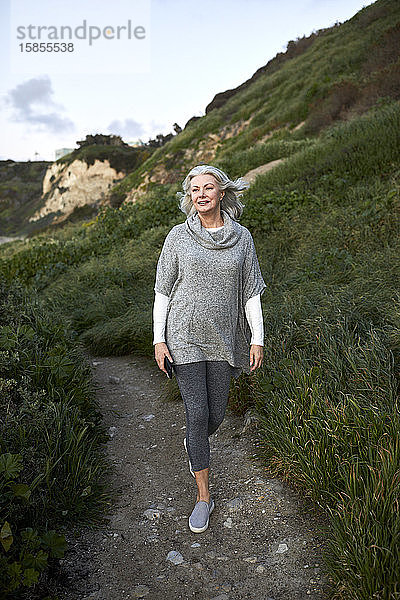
[0,284,109,598]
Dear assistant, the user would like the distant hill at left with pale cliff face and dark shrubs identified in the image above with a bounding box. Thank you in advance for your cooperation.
[0,134,152,235]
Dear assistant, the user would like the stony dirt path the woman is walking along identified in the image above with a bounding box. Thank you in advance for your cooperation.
[60,356,325,600]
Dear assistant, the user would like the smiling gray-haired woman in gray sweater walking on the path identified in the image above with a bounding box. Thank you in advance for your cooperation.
[153,165,266,533]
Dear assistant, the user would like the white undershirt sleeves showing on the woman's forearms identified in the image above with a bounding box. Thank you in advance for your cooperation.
[153,292,264,346]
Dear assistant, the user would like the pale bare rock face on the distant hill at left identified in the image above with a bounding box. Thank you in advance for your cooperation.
[30,159,125,221]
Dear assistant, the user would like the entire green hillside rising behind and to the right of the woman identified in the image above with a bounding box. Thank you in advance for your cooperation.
[0,0,400,600]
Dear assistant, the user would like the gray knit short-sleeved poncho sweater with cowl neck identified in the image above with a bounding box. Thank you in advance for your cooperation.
[154,211,266,377]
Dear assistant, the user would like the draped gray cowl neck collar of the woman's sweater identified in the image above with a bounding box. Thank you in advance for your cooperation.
[186,210,242,250]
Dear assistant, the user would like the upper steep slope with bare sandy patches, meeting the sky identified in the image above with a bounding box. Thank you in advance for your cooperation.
[114,0,400,201]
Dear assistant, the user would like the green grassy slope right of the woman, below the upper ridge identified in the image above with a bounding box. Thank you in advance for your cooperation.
[236,99,400,600]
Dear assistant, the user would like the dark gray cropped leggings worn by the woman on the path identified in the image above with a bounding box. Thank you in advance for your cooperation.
[175,360,233,471]
